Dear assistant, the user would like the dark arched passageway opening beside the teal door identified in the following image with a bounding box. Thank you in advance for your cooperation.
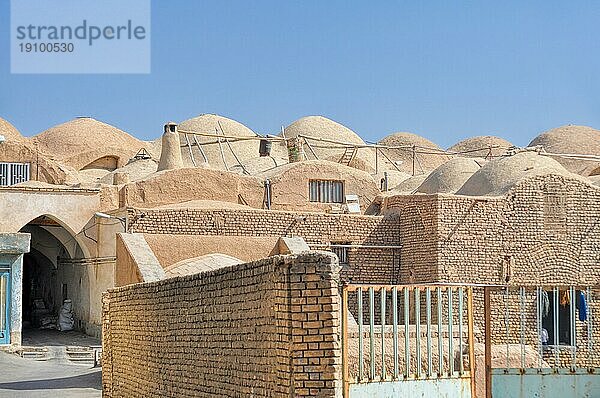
[20,216,90,345]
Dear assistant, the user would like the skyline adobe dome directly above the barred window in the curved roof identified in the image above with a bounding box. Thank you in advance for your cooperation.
[280,116,375,171]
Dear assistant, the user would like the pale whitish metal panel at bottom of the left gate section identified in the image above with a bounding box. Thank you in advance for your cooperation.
[350,377,472,398]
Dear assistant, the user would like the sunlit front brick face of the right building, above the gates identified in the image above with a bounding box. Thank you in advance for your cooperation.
[438,175,600,286]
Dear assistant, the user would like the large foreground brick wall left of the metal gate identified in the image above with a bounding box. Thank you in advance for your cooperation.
[102,252,341,397]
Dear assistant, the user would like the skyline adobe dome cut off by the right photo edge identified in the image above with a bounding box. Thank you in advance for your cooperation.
[529,125,600,176]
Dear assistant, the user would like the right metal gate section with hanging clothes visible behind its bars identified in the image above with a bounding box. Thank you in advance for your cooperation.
[484,286,600,398]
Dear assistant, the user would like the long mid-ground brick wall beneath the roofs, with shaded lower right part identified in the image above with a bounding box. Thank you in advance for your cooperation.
[128,209,400,283]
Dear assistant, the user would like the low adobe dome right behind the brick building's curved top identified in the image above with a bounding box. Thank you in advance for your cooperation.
[456,151,576,196]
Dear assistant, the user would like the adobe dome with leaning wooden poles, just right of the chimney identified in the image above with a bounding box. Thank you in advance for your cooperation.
[177,113,276,170]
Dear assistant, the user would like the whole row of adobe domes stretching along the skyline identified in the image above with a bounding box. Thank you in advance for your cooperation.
[0,114,600,195]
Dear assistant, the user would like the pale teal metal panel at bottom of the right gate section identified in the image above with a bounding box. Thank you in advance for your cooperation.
[492,368,600,398]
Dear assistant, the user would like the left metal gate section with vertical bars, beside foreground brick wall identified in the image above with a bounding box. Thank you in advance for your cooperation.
[342,285,475,398]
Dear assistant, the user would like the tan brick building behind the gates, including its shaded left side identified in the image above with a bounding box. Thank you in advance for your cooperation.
[385,175,600,365]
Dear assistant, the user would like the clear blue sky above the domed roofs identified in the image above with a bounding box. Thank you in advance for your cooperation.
[0,0,600,147]
